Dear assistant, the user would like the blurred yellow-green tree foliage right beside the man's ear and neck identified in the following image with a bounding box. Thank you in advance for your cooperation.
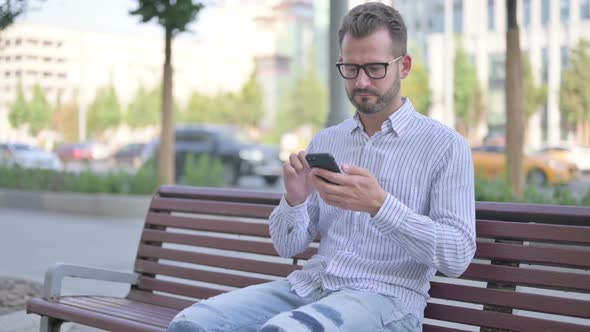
[402,61,430,115]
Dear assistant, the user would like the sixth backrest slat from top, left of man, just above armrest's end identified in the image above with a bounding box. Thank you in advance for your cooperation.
[135,259,270,287]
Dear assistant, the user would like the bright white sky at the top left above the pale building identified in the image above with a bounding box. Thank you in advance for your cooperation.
[17,0,219,36]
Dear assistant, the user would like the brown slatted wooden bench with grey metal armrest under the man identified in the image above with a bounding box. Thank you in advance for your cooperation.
[27,186,590,332]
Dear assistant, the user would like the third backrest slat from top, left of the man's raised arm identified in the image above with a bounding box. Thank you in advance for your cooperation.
[146,212,270,238]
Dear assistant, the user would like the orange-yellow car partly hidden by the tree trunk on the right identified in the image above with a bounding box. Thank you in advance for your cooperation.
[471,145,578,186]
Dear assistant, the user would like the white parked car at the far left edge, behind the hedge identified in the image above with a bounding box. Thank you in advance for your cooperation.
[0,143,62,171]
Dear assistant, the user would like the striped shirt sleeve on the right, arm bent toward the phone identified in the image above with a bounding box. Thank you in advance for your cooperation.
[372,138,476,277]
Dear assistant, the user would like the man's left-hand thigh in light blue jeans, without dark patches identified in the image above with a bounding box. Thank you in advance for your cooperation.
[167,280,309,332]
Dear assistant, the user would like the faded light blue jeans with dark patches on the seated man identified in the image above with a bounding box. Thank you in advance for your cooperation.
[167,280,422,332]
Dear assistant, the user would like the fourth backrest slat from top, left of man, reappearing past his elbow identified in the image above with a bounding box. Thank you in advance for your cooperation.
[141,229,315,259]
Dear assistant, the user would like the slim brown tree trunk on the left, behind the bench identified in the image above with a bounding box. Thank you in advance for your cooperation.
[159,29,174,184]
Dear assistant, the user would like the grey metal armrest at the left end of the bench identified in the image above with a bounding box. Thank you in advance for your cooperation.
[43,263,139,299]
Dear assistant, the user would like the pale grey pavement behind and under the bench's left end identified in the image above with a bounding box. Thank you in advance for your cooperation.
[0,208,143,332]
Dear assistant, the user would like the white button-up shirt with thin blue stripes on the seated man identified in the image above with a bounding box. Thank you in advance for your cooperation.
[269,98,475,319]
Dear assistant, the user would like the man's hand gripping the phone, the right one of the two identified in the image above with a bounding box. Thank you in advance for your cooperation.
[311,164,387,216]
